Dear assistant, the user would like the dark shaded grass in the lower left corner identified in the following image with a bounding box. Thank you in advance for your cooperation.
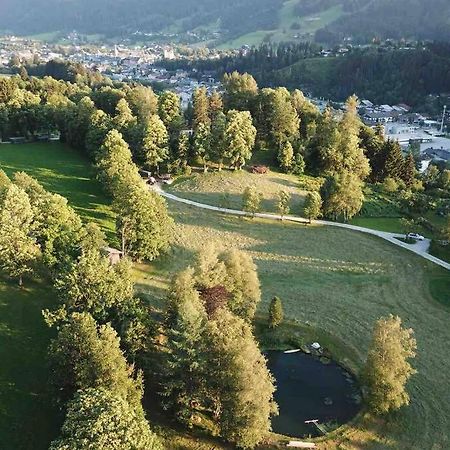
[0,277,60,450]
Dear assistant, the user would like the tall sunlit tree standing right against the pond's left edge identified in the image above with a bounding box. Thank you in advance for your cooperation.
[205,309,277,448]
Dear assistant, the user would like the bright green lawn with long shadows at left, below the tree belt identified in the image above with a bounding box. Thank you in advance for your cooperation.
[0,142,114,239]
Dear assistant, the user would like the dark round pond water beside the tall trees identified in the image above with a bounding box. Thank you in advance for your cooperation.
[266,351,360,437]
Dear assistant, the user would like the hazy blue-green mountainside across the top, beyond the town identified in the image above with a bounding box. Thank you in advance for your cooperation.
[0,0,450,47]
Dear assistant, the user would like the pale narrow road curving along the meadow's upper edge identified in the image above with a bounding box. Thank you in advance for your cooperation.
[153,185,450,270]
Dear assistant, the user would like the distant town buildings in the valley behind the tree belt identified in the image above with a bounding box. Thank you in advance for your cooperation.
[0,32,450,166]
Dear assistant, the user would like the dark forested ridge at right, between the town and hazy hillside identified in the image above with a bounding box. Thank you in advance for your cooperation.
[163,42,450,107]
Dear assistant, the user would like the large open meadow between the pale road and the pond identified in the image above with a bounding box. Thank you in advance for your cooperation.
[138,202,450,450]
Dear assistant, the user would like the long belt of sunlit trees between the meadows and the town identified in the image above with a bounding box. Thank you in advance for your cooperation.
[0,67,436,223]
